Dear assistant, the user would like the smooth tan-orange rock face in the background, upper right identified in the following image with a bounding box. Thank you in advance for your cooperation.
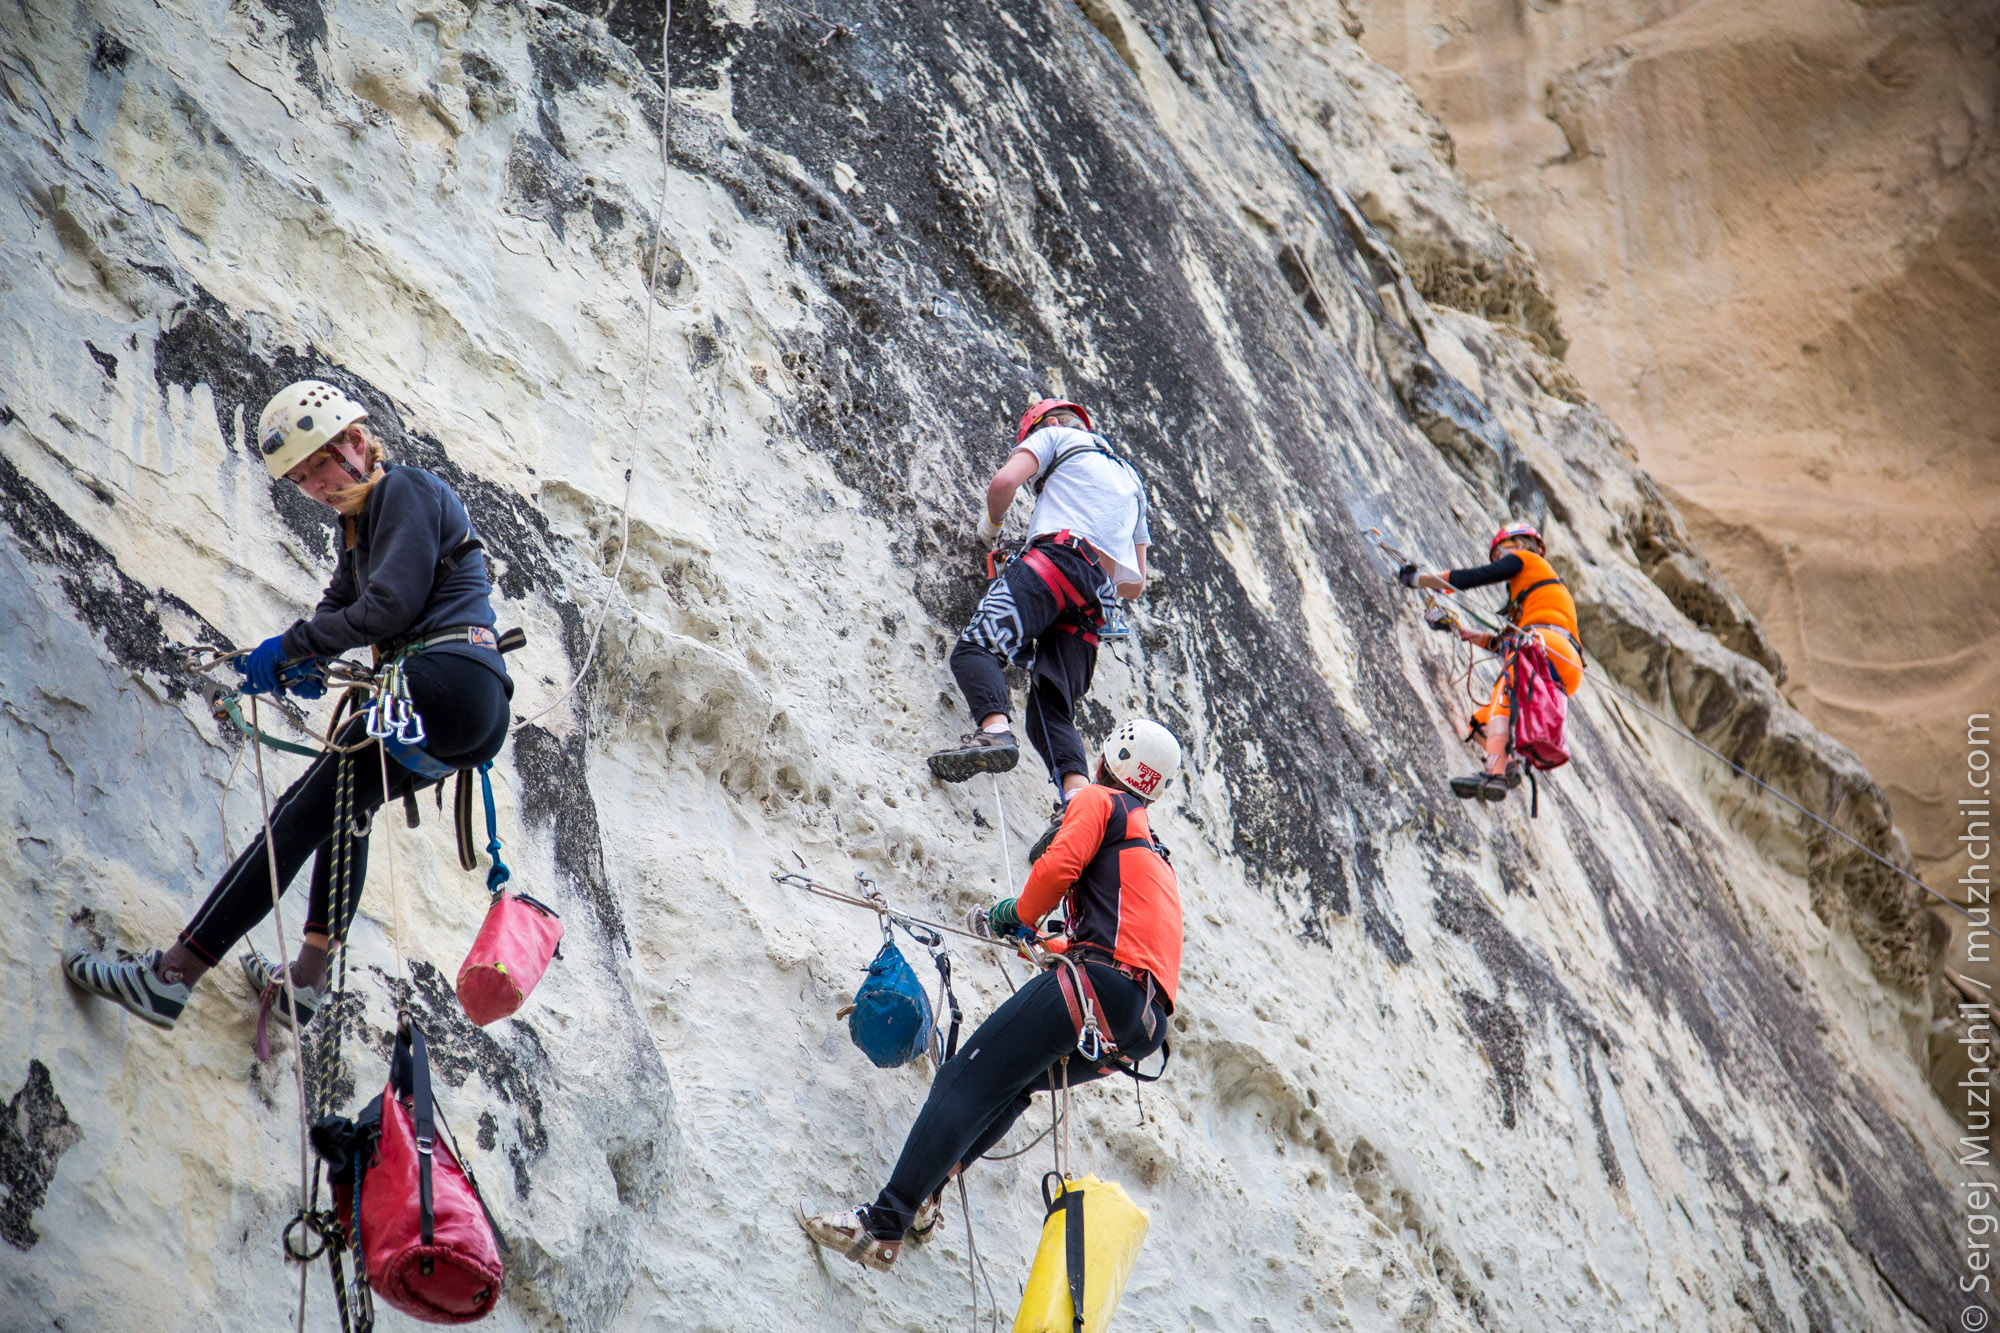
[1354,0,2000,904]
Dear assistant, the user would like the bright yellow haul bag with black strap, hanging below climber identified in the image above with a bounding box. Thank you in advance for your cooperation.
[1014,1171,1152,1333]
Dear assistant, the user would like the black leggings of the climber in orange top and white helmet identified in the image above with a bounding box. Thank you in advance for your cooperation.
[868,963,1166,1241]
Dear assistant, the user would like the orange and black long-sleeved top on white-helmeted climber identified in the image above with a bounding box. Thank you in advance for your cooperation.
[1014,783,1180,1013]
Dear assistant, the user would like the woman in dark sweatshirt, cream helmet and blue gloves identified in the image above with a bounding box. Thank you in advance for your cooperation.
[64,380,514,1027]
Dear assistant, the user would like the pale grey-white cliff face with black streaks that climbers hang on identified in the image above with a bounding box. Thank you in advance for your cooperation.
[0,0,1982,1329]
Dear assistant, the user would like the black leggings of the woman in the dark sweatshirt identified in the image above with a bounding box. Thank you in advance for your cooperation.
[180,652,508,967]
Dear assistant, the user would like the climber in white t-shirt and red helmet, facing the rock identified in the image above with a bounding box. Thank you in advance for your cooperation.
[930,398,1152,820]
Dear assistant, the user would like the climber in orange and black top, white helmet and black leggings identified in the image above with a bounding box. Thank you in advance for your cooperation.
[802,719,1182,1269]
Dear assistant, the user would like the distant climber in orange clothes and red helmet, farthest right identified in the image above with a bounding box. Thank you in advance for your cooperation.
[1396,522,1584,801]
